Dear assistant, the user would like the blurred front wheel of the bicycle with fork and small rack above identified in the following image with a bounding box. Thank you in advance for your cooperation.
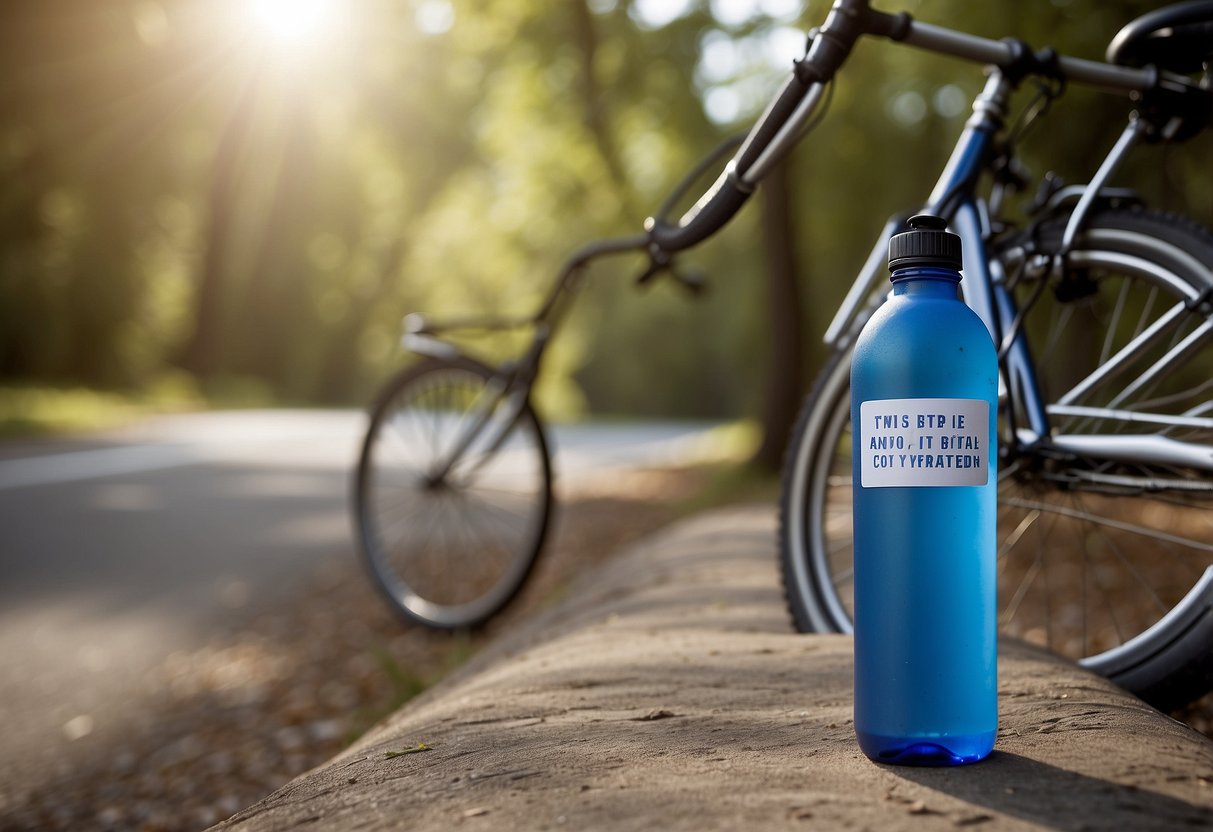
[353,139,722,629]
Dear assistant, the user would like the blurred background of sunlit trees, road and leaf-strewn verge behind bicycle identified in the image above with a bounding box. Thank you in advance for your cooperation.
[0,0,1213,828]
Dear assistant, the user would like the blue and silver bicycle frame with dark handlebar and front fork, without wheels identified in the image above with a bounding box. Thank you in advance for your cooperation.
[405,0,1213,480]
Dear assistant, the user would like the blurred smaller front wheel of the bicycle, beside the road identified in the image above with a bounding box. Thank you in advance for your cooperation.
[354,358,552,629]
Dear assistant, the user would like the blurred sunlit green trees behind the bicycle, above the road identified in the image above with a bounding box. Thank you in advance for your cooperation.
[0,0,1213,424]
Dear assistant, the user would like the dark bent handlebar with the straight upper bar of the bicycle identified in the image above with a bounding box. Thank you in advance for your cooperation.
[644,0,1190,253]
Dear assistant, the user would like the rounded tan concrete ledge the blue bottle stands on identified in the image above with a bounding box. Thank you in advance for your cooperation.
[220,508,1213,832]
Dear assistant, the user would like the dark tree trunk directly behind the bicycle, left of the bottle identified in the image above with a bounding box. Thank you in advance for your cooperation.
[753,161,804,471]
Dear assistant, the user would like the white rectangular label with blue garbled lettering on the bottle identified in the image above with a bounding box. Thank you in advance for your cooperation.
[854,399,992,489]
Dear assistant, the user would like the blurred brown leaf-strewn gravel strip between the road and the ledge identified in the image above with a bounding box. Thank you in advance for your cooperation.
[0,472,1213,831]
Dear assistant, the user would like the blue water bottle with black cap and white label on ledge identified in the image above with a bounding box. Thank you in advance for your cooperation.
[850,215,998,765]
